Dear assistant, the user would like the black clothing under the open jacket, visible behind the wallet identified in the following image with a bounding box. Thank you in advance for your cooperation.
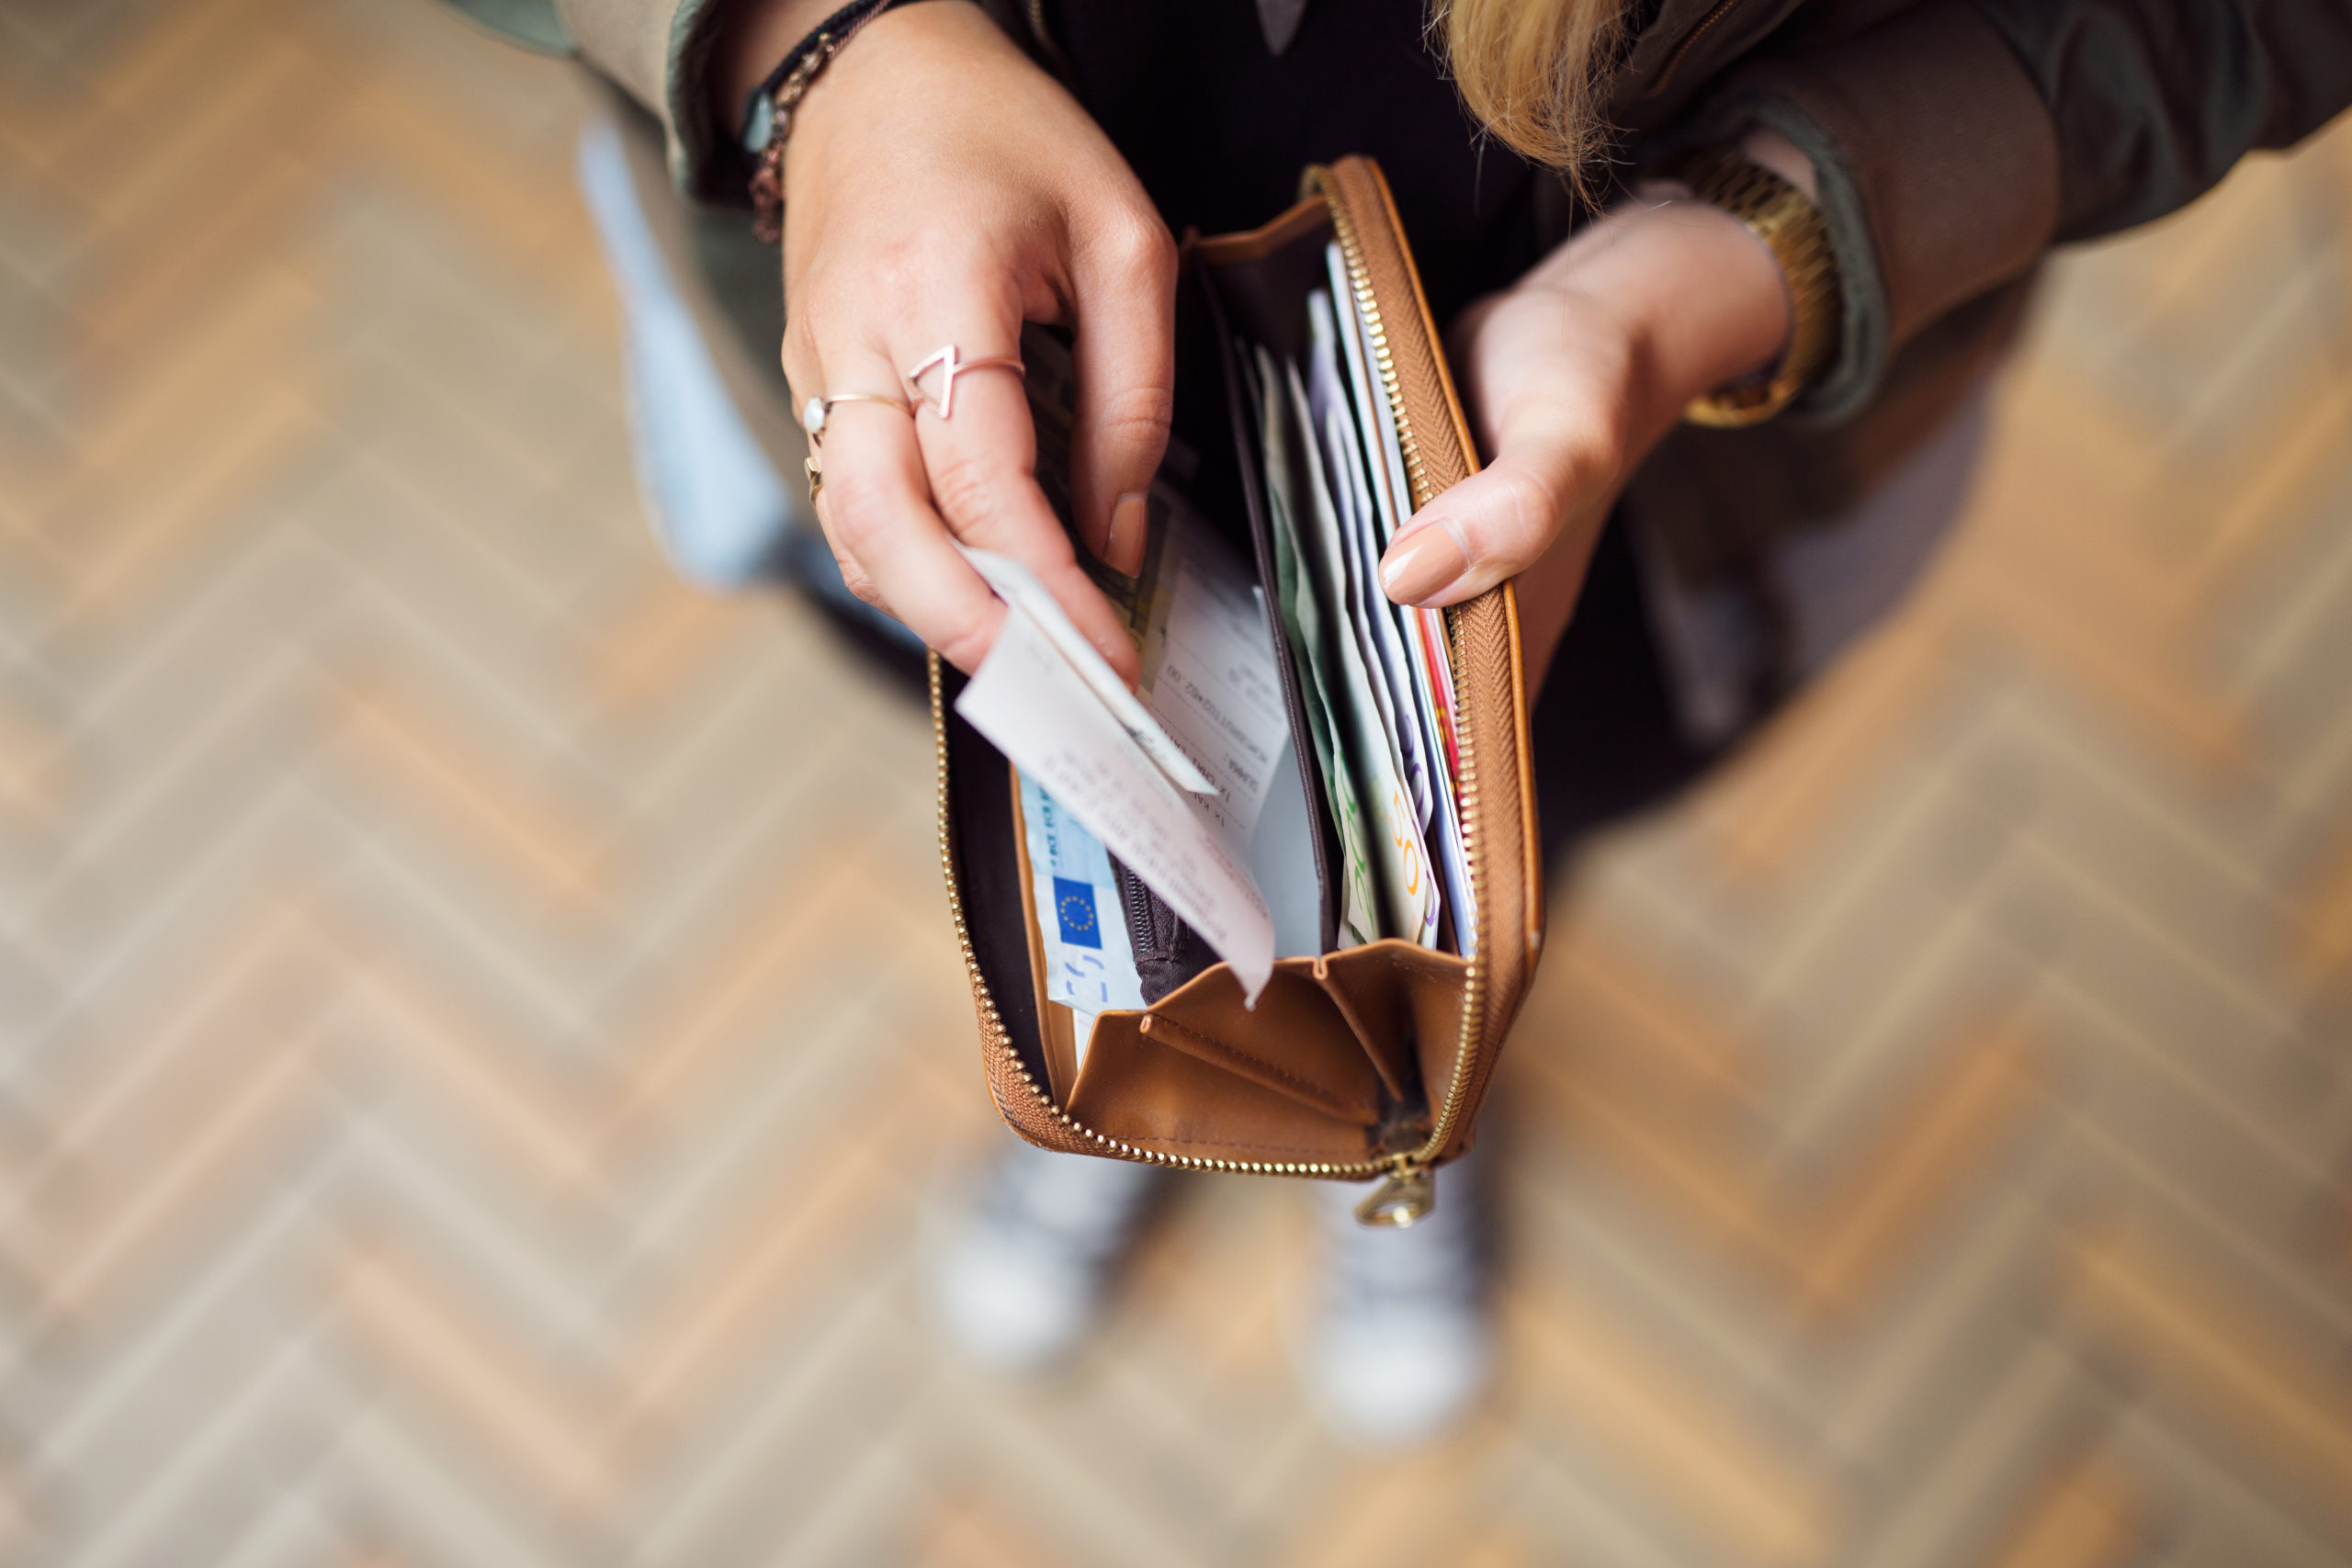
[1046,0,1713,853]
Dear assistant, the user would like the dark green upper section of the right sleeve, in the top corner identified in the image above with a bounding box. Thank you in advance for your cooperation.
[1971,0,2352,240]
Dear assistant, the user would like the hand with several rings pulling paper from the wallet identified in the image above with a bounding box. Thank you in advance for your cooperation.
[783,0,1176,682]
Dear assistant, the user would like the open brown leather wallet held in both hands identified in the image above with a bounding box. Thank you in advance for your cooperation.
[932,157,1543,1224]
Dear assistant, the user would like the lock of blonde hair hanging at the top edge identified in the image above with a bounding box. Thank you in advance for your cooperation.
[1430,0,1628,200]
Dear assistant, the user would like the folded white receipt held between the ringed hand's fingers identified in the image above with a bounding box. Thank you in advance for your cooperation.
[955,557,1280,1001]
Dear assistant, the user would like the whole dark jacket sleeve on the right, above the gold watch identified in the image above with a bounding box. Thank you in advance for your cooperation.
[1698,0,2352,421]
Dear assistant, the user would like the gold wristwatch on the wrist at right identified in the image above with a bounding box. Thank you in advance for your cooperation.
[1651,146,1844,428]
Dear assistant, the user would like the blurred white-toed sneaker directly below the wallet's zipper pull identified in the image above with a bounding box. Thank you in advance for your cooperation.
[1301,1159,1494,1448]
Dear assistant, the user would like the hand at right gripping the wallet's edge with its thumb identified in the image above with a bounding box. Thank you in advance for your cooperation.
[1381,136,1811,672]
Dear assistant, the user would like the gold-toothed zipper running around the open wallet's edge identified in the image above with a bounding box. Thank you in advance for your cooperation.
[929,164,1491,1224]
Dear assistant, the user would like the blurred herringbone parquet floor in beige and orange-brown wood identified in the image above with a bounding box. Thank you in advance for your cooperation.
[0,0,2352,1568]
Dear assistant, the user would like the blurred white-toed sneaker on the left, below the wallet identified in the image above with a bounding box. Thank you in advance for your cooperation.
[932,1143,1167,1373]
